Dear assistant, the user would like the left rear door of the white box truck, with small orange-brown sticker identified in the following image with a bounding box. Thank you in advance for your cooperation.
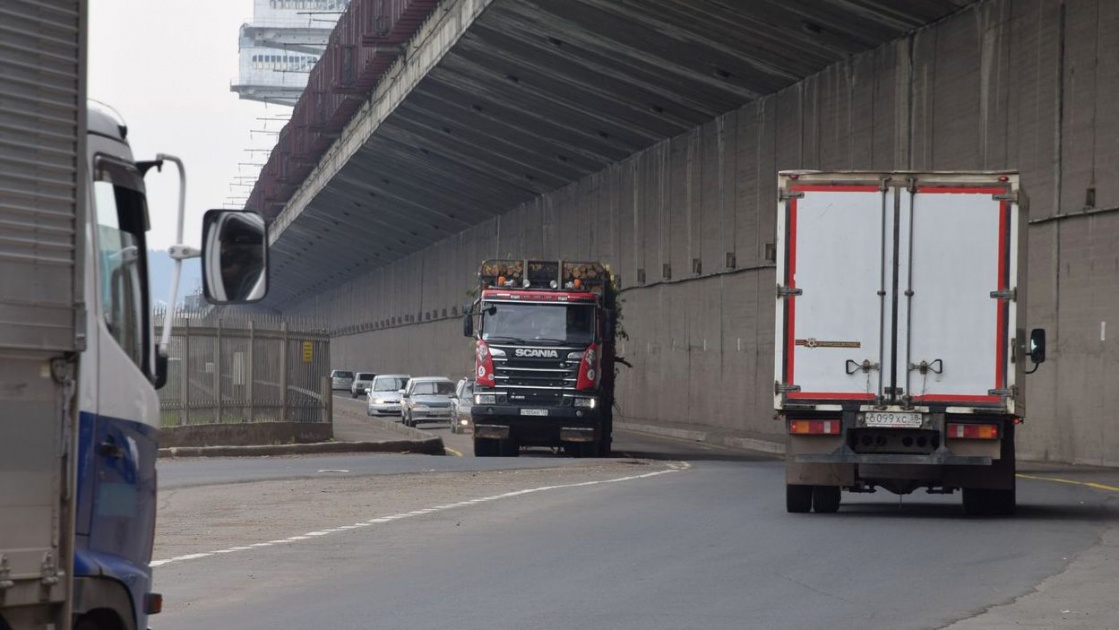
[777,179,892,401]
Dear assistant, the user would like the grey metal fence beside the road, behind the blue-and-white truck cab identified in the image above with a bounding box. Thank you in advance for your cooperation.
[153,309,331,427]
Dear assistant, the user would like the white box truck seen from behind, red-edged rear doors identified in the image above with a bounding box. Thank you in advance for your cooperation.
[774,171,1045,515]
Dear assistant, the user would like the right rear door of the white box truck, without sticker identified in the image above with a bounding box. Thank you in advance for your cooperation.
[899,177,1017,405]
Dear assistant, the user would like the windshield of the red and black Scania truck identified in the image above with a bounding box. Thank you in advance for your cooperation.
[481,302,594,346]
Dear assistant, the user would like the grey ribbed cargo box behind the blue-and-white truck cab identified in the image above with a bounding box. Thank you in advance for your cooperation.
[0,0,86,630]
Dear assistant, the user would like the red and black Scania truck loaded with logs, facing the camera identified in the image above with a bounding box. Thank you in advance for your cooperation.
[463,260,617,457]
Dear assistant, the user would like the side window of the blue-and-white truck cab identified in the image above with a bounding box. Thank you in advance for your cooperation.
[93,159,149,369]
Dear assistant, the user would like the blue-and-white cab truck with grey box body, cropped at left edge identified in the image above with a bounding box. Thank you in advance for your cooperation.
[0,0,267,630]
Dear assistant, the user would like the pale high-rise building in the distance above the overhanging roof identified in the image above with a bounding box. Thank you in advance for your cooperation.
[231,0,349,106]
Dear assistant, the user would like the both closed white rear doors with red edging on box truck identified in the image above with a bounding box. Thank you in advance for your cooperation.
[775,173,1019,407]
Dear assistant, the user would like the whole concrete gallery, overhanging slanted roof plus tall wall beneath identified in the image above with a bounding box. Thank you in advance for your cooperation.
[248,0,1119,464]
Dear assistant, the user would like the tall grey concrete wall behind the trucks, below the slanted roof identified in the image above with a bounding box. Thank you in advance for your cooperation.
[284,0,1119,466]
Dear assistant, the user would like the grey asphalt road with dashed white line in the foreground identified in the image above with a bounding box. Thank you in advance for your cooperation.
[152,422,1119,630]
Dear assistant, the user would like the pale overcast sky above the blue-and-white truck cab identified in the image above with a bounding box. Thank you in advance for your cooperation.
[87,0,291,250]
